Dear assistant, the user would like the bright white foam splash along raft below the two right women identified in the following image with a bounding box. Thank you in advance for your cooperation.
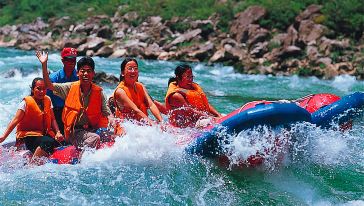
[81,122,183,164]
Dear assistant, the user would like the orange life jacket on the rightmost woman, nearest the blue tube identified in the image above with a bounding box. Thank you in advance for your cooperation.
[165,82,210,128]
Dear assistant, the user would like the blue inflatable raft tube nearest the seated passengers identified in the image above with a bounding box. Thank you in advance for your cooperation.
[186,103,311,157]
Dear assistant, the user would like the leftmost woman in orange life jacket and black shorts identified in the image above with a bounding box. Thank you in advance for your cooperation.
[0,78,64,163]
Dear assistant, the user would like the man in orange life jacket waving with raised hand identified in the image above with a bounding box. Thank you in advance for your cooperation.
[36,51,111,148]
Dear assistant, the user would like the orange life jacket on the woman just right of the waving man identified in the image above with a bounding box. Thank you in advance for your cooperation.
[114,82,148,121]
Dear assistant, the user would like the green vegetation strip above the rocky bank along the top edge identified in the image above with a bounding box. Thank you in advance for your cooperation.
[0,0,364,39]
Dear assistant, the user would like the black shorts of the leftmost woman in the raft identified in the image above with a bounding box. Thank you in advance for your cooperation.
[23,136,61,154]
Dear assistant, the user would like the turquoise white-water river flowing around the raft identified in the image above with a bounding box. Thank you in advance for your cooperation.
[0,49,364,205]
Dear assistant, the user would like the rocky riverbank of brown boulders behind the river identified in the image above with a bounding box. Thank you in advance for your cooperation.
[0,5,364,79]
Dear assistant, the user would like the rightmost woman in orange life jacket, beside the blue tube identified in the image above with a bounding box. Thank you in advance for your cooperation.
[155,64,222,128]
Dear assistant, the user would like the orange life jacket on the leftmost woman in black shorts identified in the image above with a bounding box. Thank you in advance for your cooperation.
[16,96,55,139]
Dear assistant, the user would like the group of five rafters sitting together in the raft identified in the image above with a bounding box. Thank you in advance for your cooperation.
[0,47,221,163]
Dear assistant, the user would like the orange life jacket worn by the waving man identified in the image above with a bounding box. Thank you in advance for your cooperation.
[62,81,108,140]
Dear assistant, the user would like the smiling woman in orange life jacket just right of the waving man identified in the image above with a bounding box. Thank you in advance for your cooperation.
[112,58,162,124]
